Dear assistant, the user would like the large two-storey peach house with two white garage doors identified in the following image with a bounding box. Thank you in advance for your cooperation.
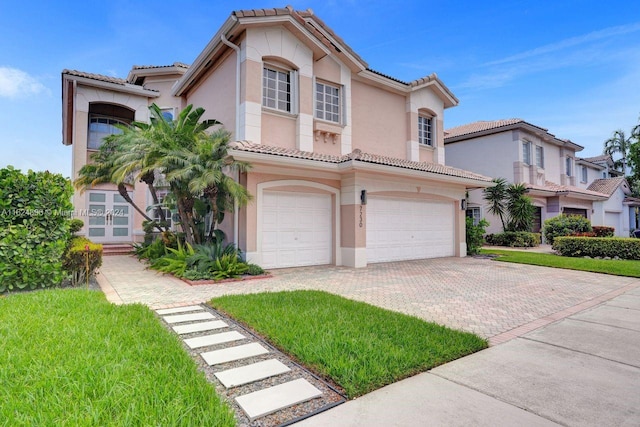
[62,7,490,268]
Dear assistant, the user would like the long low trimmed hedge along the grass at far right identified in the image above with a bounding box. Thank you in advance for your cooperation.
[553,237,640,260]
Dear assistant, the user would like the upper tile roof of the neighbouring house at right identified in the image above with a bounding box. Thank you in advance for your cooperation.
[444,118,584,151]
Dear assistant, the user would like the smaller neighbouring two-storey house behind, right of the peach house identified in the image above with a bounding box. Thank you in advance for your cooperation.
[445,119,616,236]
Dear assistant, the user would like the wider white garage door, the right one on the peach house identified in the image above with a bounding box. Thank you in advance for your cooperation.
[367,198,455,262]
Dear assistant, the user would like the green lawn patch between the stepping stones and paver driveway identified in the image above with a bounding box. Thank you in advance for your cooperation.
[211,291,487,398]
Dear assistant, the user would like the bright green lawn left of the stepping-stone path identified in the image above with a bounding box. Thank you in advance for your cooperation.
[0,289,235,426]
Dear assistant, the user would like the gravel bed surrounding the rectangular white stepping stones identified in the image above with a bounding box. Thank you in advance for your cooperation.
[159,304,346,427]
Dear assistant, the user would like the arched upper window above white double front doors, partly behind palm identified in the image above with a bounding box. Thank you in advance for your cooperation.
[87,103,135,150]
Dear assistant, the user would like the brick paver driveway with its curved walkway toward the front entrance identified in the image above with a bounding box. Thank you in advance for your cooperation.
[99,256,640,344]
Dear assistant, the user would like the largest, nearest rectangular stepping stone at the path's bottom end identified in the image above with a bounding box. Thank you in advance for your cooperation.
[236,378,322,421]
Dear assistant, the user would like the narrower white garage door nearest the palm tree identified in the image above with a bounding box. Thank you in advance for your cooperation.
[261,191,332,268]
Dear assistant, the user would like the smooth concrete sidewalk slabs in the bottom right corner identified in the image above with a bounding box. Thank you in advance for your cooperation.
[296,288,640,427]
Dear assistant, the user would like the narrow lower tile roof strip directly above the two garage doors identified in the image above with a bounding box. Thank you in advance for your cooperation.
[232,141,491,182]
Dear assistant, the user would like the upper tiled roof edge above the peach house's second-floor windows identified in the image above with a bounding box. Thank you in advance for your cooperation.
[173,6,459,108]
